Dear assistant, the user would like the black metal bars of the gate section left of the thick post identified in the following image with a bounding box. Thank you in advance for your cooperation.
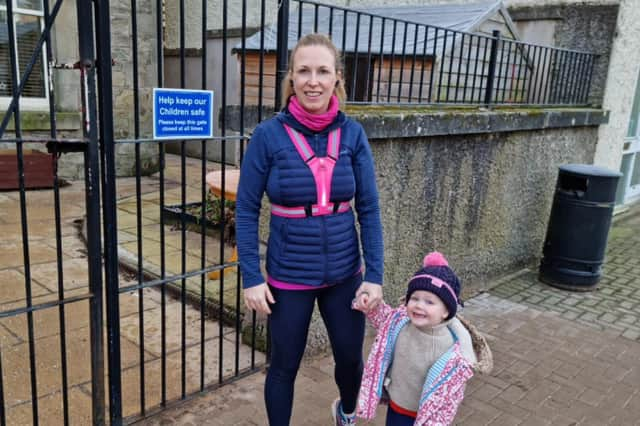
[0,0,104,425]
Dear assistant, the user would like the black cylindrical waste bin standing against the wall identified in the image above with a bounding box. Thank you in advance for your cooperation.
[539,164,622,291]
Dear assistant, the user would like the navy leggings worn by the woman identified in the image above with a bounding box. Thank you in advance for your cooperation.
[264,274,365,426]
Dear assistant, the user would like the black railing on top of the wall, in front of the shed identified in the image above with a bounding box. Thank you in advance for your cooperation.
[278,0,597,106]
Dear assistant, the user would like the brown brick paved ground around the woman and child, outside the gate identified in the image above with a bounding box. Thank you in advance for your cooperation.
[145,205,640,426]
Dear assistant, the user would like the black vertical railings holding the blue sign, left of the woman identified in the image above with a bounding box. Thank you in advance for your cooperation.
[97,0,266,424]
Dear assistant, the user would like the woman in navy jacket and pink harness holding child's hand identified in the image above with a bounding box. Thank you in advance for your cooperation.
[236,34,383,426]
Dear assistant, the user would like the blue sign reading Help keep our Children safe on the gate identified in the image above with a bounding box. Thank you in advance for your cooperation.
[153,87,213,139]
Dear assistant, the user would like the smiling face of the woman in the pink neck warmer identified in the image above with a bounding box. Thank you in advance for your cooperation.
[291,45,338,114]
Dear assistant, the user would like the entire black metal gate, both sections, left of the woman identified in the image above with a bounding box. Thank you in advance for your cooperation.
[0,0,267,426]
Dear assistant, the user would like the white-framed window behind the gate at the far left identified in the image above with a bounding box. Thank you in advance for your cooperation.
[0,0,47,107]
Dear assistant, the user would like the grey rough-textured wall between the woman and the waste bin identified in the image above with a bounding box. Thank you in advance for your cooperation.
[371,127,597,300]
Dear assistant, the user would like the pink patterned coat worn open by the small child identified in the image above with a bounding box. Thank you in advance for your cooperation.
[357,303,473,426]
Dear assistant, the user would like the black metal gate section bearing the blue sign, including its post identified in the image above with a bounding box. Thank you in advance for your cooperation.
[94,0,266,424]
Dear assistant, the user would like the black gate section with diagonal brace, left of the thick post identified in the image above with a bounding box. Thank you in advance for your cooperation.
[0,1,105,425]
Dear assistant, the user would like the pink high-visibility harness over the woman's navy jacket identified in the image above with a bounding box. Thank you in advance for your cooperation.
[271,124,351,218]
